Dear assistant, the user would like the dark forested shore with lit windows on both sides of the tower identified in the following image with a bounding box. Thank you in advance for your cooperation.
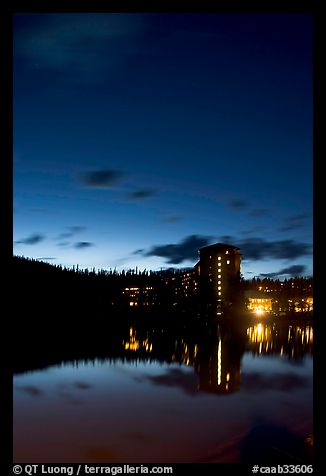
[12,256,313,319]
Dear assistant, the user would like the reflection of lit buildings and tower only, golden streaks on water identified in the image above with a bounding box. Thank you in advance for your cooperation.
[116,323,313,394]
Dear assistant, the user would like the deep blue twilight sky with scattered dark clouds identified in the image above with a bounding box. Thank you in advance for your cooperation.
[13,13,313,279]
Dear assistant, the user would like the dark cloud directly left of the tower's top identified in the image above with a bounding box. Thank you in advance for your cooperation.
[143,235,212,264]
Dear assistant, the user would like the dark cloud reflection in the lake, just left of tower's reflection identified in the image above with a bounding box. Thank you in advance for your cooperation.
[144,369,198,396]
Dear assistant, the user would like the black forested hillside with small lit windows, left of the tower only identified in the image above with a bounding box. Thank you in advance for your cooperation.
[13,256,197,315]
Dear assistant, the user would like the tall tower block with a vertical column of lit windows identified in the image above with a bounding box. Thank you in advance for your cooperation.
[199,243,241,313]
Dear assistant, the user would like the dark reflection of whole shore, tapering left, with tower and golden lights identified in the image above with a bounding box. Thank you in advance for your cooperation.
[14,322,313,394]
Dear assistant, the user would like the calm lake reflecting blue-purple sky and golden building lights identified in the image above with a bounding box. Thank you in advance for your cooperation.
[14,322,313,463]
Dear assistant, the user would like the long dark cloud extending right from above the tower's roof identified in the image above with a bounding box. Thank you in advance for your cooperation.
[220,235,312,260]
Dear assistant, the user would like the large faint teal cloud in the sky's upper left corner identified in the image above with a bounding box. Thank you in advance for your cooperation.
[14,13,143,84]
